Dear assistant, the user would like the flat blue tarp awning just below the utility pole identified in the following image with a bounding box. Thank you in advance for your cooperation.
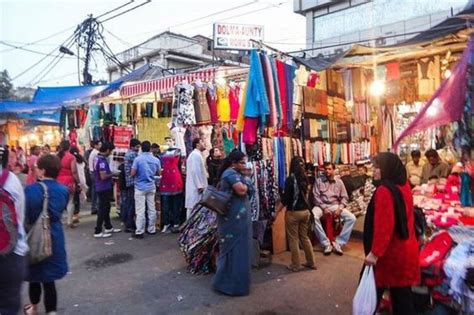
[33,84,110,105]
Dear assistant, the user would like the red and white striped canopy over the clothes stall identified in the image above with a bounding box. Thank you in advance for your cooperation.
[120,68,216,98]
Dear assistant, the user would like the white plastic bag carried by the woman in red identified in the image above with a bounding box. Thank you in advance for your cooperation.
[352,266,377,315]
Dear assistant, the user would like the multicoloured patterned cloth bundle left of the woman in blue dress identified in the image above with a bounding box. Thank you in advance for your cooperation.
[178,206,219,274]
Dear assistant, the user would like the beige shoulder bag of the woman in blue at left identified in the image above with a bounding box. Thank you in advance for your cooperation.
[26,182,53,265]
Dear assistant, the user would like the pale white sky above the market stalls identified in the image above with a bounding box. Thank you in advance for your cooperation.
[0,0,306,87]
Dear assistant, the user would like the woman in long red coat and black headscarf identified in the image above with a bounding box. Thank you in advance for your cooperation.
[364,152,420,315]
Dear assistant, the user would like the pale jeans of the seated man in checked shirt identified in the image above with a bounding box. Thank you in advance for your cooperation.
[313,205,356,247]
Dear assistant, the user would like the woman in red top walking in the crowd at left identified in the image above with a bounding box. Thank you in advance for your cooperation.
[57,140,79,228]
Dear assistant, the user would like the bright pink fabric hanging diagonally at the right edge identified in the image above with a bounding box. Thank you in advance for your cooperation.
[393,38,474,150]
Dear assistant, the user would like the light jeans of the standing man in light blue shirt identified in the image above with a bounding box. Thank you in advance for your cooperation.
[135,188,156,234]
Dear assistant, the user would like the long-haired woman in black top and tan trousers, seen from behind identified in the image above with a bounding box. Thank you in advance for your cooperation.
[280,156,316,271]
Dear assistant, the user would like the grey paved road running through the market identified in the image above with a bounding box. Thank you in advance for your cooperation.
[24,211,362,315]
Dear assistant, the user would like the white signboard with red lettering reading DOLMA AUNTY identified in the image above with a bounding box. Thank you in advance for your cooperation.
[214,22,264,50]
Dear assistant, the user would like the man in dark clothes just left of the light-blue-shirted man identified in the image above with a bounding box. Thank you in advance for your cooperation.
[121,139,141,233]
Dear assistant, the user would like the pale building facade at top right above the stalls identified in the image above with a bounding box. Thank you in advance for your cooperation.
[293,0,468,56]
